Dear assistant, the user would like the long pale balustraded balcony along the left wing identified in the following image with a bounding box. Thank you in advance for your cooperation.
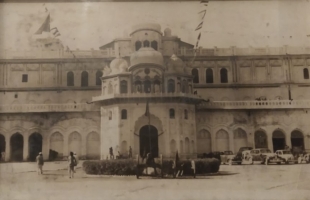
[0,103,100,113]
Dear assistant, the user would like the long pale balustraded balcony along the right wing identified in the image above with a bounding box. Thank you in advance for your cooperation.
[198,100,310,109]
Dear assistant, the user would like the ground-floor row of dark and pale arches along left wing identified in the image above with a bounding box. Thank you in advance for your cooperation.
[0,131,100,162]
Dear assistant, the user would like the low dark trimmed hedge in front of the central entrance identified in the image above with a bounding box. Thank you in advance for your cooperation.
[83,158,220,175]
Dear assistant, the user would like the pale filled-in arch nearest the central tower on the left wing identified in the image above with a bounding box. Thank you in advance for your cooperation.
[86,132,100,159]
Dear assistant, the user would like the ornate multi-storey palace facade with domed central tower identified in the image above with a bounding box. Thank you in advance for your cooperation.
[0,24,310,161]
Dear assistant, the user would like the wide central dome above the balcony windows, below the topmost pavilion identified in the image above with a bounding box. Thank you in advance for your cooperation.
[130,47,164,68]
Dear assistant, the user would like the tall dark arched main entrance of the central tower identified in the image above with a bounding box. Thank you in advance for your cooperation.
[139,125,158,157]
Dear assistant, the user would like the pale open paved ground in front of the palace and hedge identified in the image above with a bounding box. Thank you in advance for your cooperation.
[0,162,310,200]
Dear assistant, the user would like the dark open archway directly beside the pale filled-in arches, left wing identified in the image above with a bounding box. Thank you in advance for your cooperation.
[28,133,42,161]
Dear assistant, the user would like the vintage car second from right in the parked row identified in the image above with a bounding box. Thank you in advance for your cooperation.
[265,150,295,165]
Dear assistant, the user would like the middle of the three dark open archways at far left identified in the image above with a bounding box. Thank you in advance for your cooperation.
[10,133,24,161]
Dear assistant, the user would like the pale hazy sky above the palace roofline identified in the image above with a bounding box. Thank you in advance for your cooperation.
[0,0,310,50]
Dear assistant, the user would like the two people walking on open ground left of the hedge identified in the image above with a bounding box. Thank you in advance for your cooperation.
[36,152,79,178]
